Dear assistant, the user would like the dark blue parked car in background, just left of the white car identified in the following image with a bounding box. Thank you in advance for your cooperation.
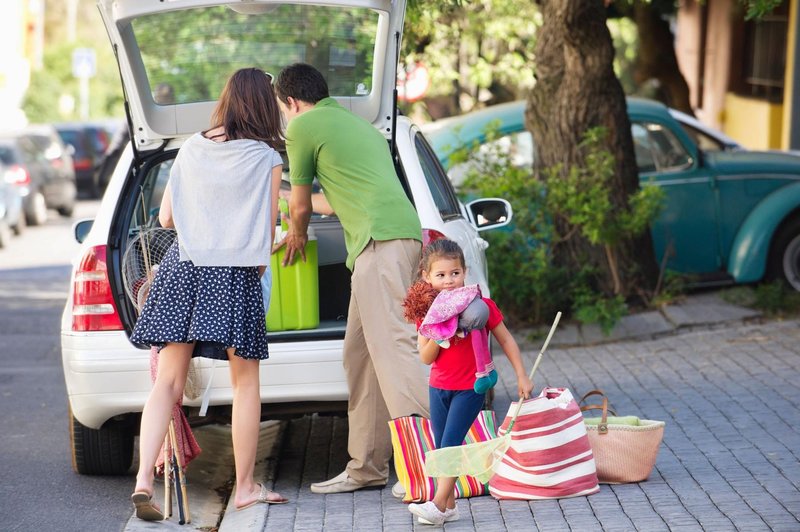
[55,122,110,198]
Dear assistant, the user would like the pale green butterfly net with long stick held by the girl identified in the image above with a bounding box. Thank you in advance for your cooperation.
[425,312,561,482]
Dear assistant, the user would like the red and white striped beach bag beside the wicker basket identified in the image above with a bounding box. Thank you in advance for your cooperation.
[489,388,599,500]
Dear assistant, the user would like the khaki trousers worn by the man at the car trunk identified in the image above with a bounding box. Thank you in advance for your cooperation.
[343,239,430,482]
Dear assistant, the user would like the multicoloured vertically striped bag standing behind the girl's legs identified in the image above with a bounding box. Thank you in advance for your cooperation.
[389,410,496,502]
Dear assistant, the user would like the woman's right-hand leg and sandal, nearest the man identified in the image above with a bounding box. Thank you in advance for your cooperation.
[228,348,281,508]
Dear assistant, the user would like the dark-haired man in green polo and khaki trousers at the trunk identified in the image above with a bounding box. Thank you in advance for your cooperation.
[275,63,429,495]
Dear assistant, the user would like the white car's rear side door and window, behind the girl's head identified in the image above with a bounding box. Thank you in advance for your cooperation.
[413,130,489,295]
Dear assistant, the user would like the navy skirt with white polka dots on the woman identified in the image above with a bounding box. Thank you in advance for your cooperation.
[131,241,269,360]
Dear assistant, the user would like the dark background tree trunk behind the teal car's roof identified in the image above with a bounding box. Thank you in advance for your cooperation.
[632,0,694,116]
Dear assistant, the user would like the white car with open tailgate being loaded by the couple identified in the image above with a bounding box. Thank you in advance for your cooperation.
[61,0,512,474]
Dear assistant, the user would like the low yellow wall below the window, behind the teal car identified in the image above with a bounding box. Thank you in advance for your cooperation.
[722,93,783,150]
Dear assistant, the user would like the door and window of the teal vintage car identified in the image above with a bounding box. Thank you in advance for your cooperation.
[631,117,722,273]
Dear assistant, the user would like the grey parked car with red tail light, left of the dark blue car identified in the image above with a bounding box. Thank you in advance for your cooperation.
[0,131,76,225]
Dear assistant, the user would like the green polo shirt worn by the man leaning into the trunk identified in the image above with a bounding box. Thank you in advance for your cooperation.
[286,98,422,270]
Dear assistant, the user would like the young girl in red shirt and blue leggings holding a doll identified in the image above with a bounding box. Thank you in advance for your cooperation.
[408,240,533,525]
